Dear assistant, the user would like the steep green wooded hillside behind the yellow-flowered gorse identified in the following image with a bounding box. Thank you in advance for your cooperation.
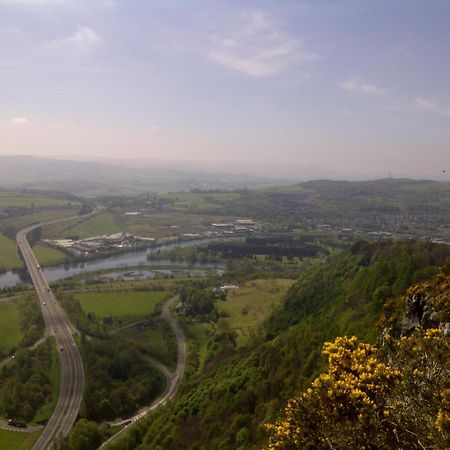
[107,242,450,449]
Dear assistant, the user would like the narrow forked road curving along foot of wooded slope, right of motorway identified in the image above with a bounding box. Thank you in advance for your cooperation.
[99,296,186,448]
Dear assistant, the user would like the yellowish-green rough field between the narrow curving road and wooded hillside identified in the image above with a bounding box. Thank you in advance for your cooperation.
[216,279,295,345]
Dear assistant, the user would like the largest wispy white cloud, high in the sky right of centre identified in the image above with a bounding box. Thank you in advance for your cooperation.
[208,12,317,77]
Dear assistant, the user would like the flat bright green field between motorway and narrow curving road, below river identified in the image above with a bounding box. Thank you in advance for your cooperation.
[75,291,167,319]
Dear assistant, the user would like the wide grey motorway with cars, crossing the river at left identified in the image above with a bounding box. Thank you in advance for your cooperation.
[17,219,84,450]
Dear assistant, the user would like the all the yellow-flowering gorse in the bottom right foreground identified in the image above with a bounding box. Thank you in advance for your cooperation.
[267,273,450,450]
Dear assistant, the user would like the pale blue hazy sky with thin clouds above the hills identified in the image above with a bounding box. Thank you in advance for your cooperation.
[0,0,450,176]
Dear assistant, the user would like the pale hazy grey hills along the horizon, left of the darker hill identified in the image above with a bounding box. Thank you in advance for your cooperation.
[0,155,444,196]
